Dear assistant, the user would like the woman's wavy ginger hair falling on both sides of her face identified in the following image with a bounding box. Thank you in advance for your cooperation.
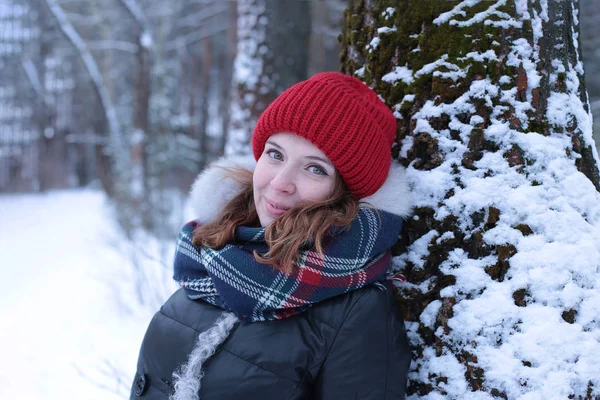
[192,168,359,273]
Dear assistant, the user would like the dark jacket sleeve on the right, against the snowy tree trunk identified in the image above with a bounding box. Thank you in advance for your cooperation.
[313,285,411,400]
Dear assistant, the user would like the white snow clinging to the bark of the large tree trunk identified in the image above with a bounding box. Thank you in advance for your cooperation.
[372,0,600,399]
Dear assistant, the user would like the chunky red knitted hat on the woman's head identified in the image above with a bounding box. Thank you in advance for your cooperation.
[252,72,396,199]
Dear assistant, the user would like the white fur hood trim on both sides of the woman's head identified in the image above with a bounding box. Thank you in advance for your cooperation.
[190,156,412,224]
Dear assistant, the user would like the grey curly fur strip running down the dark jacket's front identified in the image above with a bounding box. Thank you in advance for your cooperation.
[169,312,240,400]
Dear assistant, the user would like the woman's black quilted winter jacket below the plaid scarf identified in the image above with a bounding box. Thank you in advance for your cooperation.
[131,284,410,400]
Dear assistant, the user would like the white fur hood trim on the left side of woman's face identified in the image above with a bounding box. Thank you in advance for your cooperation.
[190,156,256,224]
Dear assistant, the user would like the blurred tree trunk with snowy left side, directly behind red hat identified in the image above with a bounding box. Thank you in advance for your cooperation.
[226,0,310,154]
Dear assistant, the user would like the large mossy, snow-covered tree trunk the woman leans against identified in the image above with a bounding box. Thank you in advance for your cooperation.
[341,0,600,399]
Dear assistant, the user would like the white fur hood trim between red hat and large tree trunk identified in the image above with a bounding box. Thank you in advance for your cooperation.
[361,160,412,218]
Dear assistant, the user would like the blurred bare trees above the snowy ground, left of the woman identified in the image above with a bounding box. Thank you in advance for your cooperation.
[0,0,346,236]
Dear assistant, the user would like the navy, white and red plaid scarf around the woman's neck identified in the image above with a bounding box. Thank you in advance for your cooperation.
[173,208,402,322]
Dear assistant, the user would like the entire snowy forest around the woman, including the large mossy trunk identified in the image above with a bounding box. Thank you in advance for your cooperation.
[0,0,600,400]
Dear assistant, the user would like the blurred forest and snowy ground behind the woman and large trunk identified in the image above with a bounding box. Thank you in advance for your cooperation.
[0,0,600,399]
